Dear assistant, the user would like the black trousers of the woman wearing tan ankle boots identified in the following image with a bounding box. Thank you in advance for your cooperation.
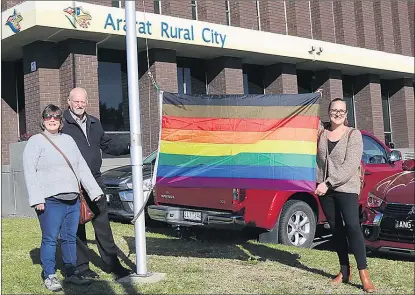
[319,190,367,273]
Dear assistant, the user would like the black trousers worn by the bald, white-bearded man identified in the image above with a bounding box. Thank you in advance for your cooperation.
[76,180,121,272]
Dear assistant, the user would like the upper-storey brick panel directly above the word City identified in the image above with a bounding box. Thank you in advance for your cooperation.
[197,0,226,25]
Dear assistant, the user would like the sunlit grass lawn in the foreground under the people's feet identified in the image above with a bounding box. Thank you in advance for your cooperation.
[1,218,414,294]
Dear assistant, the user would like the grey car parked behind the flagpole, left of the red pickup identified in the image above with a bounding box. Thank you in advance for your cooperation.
[102,152,157,221]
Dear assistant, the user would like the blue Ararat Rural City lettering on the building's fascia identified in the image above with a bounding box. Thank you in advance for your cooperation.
[104,13,226,48]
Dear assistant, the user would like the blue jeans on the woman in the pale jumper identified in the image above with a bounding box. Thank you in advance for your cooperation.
[37,197,80,278]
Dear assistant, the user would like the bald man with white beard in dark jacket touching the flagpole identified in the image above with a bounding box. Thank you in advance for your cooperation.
[62,87,130,278]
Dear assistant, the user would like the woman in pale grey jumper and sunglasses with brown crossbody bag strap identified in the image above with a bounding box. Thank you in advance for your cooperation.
[23,105,103,291]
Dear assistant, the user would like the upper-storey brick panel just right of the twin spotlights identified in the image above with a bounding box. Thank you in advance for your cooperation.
[333,0,357,46]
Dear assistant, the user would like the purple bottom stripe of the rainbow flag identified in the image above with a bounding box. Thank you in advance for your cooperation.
[156,177,316,192]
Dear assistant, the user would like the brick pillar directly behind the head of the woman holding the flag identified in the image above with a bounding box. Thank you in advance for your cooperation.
[314,70,343,121]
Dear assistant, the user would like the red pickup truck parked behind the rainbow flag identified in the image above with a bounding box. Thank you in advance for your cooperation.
[147,131,402,247]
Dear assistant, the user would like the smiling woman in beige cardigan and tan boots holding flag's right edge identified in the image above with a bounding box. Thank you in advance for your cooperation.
[315,98,375,293]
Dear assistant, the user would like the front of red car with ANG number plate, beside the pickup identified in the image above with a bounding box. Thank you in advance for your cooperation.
[362,160,415,255]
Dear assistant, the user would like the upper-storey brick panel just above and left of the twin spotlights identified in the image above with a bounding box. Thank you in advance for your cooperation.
[285,1,311,38]
